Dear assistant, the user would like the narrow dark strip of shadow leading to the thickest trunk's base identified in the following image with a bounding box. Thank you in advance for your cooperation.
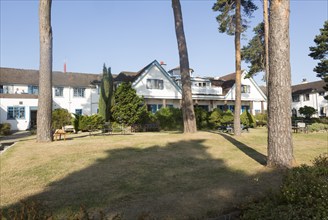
[219,133,267,166]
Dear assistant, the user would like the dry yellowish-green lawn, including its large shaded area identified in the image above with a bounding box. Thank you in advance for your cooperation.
[0,128,328,219]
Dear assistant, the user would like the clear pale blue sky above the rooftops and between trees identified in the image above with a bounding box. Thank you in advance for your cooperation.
[0,0,328,84]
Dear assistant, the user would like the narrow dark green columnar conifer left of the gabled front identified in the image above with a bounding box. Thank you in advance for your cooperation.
[99,64,114,122]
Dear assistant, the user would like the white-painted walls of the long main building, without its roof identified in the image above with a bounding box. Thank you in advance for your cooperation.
[0,60,266,130]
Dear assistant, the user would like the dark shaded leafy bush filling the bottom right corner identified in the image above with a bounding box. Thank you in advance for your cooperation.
[242,155,328,220]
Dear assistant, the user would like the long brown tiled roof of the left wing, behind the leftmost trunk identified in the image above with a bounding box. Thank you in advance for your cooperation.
[0,67,101,87]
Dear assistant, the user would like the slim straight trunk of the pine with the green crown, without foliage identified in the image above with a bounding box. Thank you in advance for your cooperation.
[233,0,241,136]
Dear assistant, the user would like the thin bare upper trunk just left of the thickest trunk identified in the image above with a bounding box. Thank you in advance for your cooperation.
[263,0,269,85]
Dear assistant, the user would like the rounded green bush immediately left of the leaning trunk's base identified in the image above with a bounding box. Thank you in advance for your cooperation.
[155,107,183,131]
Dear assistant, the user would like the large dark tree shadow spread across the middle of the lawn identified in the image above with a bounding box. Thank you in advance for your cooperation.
[5,136,280,219]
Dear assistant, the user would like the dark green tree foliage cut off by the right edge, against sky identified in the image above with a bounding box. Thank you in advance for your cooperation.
[309,20,328,100]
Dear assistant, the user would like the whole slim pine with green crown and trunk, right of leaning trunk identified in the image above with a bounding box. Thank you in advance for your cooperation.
[212,0,257,136]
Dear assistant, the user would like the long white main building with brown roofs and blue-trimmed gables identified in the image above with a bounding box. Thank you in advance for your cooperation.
[0,60,266,130]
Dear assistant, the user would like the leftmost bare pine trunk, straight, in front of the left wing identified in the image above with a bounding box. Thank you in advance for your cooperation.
[37,0,52,142]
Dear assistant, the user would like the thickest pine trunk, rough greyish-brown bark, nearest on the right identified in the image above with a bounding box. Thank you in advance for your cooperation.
[267,0,293,167]
